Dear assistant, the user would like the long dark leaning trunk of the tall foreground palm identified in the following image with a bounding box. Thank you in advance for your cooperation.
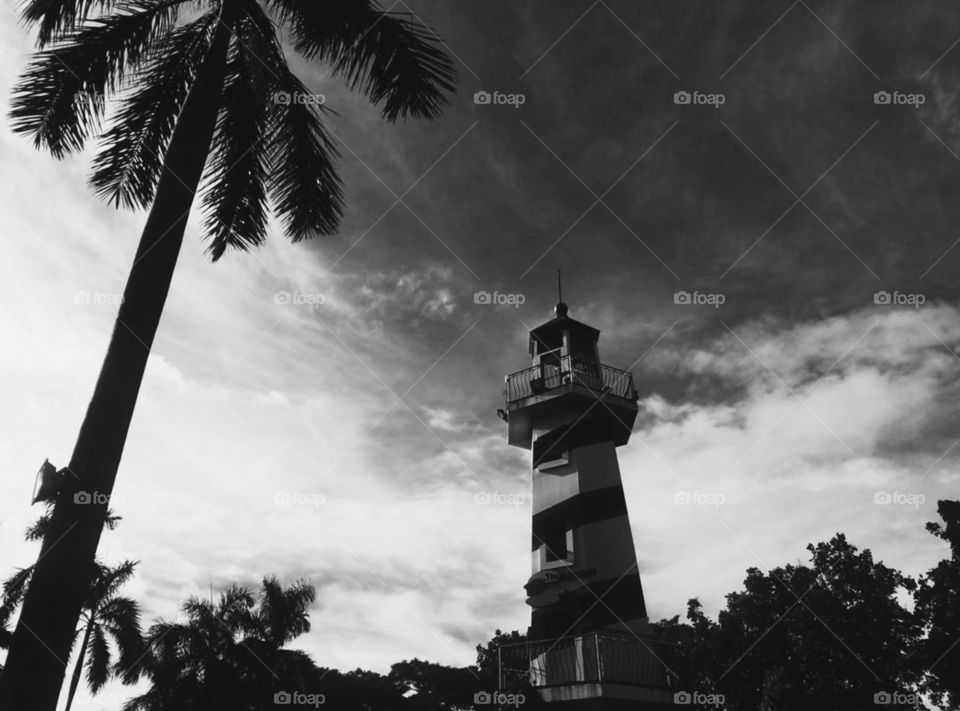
[0,21,230,711]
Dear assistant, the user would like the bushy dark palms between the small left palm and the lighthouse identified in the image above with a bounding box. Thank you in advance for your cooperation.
[124,578,317,711]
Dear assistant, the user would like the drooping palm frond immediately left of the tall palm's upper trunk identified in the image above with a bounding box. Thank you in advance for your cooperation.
[90,12,217,207]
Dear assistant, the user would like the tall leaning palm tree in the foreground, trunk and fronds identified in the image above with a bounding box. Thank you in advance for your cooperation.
[0,0,455,711]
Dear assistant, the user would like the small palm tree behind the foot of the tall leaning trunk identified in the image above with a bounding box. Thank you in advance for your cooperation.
[0,560,144,711]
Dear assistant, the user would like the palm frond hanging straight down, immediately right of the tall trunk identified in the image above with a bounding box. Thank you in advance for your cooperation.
[202,13,267,261]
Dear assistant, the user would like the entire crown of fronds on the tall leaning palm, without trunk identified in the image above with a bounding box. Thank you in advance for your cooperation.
[10,0,455,260]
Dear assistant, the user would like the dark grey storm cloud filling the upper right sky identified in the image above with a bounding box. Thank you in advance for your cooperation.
[292,1,960,434]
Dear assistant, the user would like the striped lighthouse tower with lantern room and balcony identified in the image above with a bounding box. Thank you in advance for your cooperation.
[499,301,677,711]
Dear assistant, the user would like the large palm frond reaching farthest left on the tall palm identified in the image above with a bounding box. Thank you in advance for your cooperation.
[10,0,185,158]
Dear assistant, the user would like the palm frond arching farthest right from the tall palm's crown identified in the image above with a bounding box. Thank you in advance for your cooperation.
[267,0,457,121]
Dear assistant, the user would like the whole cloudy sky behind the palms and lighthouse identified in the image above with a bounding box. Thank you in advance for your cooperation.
[0,0,960,709]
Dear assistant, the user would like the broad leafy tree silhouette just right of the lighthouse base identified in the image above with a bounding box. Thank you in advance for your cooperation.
[658,534,919,711]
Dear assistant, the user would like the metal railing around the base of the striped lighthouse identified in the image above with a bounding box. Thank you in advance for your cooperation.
[499,632,685,689]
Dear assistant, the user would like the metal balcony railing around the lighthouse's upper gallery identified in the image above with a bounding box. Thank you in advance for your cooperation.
[504,356,636,403]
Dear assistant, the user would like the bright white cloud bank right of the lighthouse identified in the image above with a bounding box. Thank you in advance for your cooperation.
[621,305,960,616]
